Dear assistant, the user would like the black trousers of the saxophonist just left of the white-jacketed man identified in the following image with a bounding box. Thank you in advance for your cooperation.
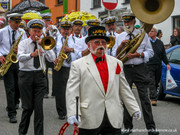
[53,67,70,116]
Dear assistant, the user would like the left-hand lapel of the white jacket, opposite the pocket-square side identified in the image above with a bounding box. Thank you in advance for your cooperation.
[86,54,105,95]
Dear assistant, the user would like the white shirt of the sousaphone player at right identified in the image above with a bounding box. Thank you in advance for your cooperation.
[113,29,154,65]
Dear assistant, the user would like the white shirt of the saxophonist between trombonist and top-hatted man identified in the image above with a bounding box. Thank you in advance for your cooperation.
[56,34,78,67]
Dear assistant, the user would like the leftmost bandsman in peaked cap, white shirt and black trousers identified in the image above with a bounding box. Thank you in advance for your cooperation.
[0,13,27,123]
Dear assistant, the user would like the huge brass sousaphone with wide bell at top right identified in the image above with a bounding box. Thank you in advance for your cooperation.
[117,0,175,63]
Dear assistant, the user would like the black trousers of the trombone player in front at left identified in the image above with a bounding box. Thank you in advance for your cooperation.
[19,71,47,135]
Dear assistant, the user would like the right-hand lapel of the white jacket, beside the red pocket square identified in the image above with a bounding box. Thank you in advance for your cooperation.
[106,55,117,96]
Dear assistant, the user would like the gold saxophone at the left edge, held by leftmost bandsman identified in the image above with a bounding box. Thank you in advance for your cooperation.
[0,31,23,76]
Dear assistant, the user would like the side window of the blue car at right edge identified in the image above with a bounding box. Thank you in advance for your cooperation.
[167,48,180,65]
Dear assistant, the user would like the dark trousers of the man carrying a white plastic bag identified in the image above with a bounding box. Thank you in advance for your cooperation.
[147,64,162,101]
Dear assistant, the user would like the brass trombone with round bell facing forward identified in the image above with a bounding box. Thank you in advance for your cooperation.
[36,33,56,73]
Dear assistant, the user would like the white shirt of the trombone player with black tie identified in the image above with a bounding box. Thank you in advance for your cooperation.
[17,38,55,71]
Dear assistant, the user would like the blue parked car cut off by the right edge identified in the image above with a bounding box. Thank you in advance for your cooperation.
[158,45,180,99]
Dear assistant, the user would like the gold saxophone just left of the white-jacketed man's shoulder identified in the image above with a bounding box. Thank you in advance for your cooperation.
[54,36,69,71]
